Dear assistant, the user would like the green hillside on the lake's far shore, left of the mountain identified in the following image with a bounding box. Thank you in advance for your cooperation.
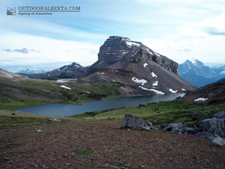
[0,78,119,110]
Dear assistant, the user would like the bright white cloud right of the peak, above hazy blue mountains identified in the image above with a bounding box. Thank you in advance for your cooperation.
[142,12,225,63]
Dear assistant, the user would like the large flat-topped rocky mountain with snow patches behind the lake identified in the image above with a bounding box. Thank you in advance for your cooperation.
[82,36,196,96]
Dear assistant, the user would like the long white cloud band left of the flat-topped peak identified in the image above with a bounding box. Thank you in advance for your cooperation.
[0,33,99,66]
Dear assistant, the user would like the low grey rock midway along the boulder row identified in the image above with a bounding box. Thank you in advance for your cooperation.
[163,123,187,134]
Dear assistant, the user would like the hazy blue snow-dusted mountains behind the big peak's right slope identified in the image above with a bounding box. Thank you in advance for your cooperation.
[179,59,225,87]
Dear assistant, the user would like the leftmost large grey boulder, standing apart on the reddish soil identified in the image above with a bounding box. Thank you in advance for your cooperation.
[121,115,150,130]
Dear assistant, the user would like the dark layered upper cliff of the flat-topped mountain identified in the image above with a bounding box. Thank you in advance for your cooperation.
[97,36,178,74]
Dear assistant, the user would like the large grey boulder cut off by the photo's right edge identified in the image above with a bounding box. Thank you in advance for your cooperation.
[200,118,225,137]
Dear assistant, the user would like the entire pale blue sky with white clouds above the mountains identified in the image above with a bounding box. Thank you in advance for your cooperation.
[0,0,225,72]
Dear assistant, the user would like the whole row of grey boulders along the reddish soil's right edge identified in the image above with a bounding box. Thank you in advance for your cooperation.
[121,112,225,146]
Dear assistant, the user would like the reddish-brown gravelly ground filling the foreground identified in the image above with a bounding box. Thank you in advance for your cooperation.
[0,120,225,169]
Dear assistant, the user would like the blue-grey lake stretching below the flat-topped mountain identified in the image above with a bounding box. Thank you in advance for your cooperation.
[16,93,185,117]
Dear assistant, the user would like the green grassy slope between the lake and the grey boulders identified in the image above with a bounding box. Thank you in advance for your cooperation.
[72,100,225,126]
